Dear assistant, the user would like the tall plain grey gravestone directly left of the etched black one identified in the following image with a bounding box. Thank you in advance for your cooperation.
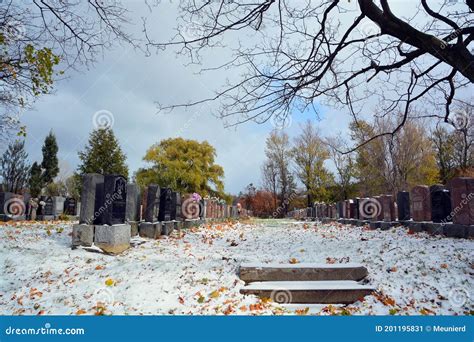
[79,173,104,224]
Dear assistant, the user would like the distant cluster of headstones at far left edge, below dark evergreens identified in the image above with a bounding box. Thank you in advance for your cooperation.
[0,192,80,221]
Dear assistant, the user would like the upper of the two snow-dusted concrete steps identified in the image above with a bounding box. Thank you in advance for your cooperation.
[239,263,367,283]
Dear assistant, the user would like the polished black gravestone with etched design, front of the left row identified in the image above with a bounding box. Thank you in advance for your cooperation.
[103,175,127,226]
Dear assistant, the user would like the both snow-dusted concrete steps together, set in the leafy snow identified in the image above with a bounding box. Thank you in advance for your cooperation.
[239,263,375,304]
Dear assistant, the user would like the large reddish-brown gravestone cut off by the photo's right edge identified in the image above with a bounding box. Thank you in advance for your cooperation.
[449,177,474,225]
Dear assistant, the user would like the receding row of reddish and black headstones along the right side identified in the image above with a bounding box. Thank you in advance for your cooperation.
[286,177,474,237]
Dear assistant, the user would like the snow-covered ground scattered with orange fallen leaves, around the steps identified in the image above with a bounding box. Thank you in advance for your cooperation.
[0,220,474,315]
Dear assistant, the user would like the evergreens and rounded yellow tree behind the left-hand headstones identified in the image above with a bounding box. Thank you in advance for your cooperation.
[0,127,232,202]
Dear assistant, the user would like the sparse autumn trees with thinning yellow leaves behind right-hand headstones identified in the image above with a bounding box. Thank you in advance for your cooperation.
[240,105,474,217]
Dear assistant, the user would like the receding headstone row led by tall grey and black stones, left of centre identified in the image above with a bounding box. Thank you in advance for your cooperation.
[72,174,242,254]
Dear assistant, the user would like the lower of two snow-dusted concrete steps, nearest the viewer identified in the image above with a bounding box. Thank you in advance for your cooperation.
[240,280,375,304]
